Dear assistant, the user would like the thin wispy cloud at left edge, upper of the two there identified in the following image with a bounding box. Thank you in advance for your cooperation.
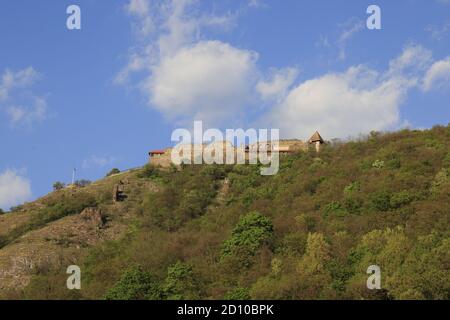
[0,67,47,125]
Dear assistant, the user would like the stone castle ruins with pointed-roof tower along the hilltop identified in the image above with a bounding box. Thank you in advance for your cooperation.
[148,131,325,167]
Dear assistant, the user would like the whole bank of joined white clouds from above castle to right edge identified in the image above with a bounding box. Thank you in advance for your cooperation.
[120,0,450,138]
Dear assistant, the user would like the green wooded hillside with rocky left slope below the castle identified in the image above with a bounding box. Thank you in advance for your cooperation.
[0,125,450,299]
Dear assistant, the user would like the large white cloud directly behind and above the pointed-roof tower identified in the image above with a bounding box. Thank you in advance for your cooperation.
[265,47,428,138]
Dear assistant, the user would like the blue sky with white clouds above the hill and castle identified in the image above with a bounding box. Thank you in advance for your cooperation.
[0,0,450,209]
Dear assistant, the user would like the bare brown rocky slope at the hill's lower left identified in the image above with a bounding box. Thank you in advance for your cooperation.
[0,208,126,294]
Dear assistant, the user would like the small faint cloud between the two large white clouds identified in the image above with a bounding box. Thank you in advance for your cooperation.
[256,68,298,100]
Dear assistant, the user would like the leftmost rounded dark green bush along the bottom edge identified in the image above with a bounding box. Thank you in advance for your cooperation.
[105,267,161,300]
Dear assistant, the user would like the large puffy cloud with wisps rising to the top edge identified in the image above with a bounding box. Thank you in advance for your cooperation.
[115,0,257,123]
